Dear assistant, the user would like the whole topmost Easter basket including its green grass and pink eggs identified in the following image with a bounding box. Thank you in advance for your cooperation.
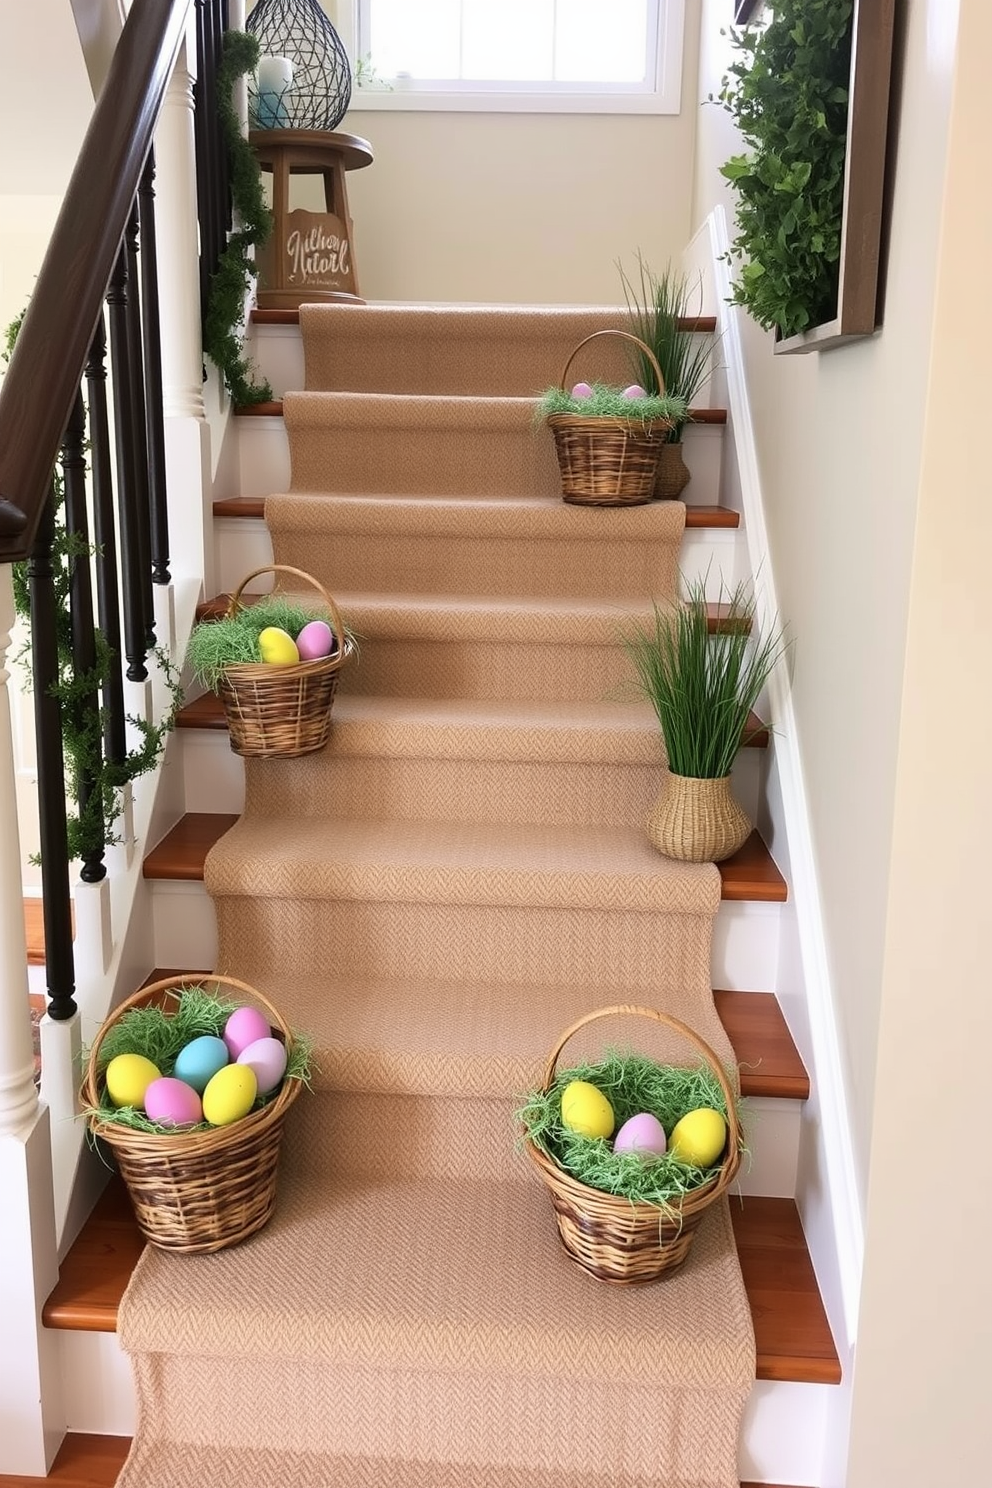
[540,330,686,506]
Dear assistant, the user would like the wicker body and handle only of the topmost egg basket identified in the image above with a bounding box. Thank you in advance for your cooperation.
[547,330,672,506]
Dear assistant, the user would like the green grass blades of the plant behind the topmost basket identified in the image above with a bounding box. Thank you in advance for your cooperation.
[617,253,712,443]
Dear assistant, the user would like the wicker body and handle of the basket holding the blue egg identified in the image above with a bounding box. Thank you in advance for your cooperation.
[80,976,302,1254]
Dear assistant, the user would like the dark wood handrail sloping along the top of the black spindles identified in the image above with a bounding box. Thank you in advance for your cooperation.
[0,0,192,562]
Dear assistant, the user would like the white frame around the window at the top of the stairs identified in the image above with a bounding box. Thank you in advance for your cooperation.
[338,0,686,113]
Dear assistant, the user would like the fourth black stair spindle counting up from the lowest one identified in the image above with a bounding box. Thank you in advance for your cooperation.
[107,243,149,682]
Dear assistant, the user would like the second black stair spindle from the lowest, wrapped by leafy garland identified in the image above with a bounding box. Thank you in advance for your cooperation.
[61,393,107,884]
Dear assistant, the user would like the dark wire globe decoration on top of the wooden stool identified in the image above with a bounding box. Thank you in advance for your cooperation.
[245,0,351,131]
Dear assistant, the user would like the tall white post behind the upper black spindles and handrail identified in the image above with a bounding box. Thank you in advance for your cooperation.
[155,21,213,586]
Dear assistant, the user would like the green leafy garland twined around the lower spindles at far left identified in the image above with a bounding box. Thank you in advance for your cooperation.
[3,311,183,862]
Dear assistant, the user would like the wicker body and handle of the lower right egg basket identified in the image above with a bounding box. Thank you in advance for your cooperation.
[524,1004,741,1283]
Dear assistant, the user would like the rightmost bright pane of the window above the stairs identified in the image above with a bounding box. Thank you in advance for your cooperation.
[555,0,647,83]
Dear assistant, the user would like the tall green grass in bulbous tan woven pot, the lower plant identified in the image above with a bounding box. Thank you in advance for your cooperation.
[623,577,790,863]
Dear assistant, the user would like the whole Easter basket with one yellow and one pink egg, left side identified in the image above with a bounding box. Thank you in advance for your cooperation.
[186,564,354,759]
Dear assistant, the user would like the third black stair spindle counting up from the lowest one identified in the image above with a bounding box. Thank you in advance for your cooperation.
[86,312,126,765]
